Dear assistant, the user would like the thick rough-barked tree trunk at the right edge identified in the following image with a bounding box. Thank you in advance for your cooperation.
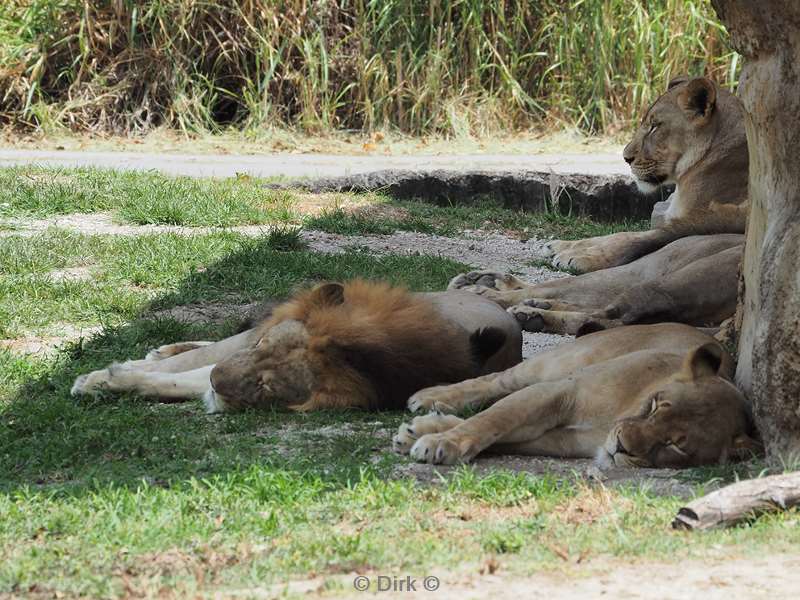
[712,0,800,459]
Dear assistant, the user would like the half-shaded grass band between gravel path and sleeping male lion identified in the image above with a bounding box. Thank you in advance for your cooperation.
[0,229,468,338]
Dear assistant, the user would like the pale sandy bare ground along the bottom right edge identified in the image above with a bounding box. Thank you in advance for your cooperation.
[256,552,800,600]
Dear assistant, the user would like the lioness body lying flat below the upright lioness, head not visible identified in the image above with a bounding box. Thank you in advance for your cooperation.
[448,233,744,335]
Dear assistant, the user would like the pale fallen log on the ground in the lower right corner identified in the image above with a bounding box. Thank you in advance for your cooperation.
[672,471,800,530]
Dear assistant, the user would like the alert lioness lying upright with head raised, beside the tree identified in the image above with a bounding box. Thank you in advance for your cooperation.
[546,76,749,273]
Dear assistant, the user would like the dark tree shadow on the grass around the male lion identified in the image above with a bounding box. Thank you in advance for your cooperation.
[0,238,466,495]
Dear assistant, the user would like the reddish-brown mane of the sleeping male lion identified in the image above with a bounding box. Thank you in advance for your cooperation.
[264,280,482,409]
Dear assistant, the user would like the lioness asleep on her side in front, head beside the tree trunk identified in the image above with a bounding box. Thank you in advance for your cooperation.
[393,323,758,467]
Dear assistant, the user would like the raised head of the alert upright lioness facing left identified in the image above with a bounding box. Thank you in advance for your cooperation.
[623,76,730,192]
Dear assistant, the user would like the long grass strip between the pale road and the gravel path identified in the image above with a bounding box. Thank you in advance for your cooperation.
[0,167,648,244]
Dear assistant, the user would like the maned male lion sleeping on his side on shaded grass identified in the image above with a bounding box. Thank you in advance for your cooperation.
[72,281,522,412]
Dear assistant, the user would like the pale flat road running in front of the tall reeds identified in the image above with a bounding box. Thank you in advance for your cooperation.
[0,150,629,178]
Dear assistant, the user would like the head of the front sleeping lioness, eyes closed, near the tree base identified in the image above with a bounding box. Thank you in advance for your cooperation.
[598,343,759,468]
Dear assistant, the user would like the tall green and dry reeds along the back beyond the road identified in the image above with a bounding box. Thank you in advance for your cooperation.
[0,0,738,136]
